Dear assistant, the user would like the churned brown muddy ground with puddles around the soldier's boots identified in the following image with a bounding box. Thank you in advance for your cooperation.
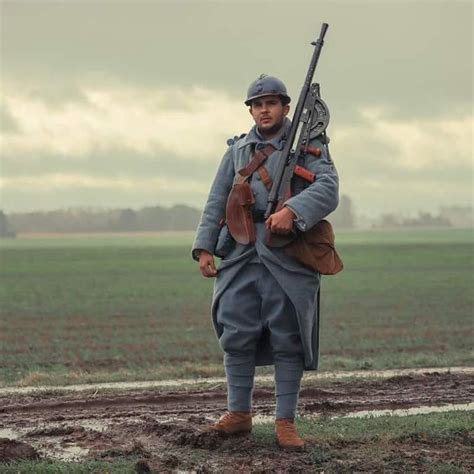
[0,373,474,472]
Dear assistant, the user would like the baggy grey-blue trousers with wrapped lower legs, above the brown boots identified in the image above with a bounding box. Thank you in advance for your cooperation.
[217,263,303,418]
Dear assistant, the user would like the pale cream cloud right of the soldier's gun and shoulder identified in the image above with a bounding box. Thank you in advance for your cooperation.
[331,106,474,213]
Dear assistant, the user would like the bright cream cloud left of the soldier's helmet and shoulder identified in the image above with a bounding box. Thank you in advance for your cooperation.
[0,86,250,162]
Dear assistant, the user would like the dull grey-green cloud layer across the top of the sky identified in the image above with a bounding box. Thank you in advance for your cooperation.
[2,0,472,120]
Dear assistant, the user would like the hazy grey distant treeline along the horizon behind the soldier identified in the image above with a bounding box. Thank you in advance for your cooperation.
[0,198,473,238]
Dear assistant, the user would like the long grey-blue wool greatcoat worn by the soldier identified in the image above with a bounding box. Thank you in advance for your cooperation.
[192,119,338,370]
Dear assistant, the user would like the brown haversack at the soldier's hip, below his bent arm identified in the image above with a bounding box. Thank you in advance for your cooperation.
[284,219,344,275]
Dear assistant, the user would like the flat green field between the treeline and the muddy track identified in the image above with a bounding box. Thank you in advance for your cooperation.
[0,230,474,385]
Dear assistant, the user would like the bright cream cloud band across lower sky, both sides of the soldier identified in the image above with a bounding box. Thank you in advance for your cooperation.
[0,84,474,213]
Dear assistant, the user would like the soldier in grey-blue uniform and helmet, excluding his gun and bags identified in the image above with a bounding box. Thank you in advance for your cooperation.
[192,75,338,449]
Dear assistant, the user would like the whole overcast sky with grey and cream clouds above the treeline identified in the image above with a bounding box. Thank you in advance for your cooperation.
[0,0,473,216]
